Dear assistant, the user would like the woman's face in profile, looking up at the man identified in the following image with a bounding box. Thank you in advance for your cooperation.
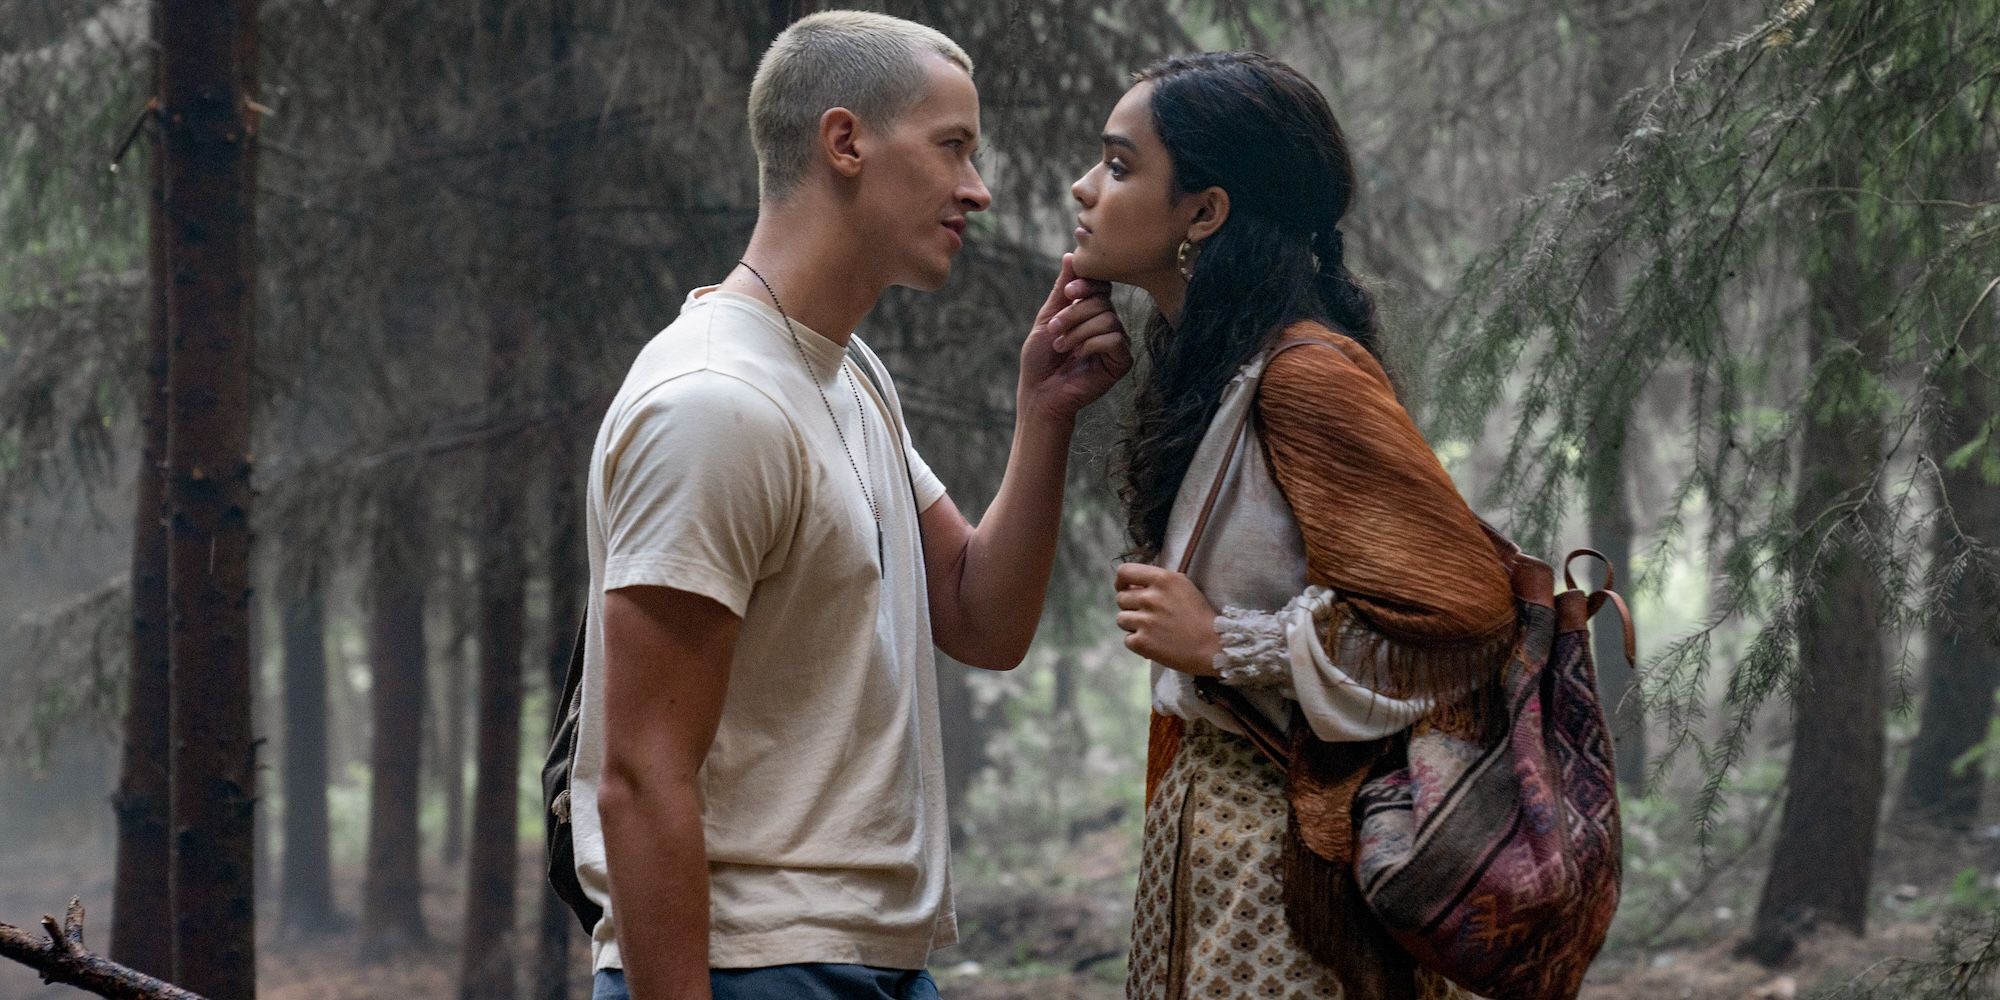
[1070,82,1194,292]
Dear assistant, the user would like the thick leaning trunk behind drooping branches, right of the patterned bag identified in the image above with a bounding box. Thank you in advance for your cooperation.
[1752,156,1888,962]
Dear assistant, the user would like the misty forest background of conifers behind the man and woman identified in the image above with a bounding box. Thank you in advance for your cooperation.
[0,0,2000,998]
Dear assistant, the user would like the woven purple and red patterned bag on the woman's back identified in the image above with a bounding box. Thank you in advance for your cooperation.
[1354,534,1634,1000]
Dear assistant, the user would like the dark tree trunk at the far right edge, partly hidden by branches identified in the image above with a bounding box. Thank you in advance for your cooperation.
[1898,304,2000,830]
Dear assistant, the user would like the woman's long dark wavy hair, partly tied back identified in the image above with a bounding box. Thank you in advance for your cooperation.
[1122,52,1376,560]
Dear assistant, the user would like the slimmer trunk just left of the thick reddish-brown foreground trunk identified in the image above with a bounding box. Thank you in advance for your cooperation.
[110,0,174,978]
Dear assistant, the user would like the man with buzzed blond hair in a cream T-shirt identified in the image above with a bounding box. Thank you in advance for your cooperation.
[572,12,1130,1000]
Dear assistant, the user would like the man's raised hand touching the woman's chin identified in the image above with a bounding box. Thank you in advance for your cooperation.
[1016,254,1132,420]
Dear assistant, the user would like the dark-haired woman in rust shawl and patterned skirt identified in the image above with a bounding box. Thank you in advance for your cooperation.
[1056,52,1516,1000]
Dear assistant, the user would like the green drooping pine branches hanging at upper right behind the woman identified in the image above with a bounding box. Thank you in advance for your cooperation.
[1434,0,2000,838]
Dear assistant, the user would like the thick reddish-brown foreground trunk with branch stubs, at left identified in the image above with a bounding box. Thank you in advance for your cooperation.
[160,0,256,996]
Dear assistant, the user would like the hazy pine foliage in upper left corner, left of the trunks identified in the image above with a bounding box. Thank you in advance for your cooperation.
[0,0,148,534]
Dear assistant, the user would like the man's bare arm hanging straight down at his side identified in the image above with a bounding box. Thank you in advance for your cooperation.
[598,586,742,1000]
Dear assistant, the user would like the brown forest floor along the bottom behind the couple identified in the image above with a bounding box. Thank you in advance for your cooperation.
[0,830,2000,1000]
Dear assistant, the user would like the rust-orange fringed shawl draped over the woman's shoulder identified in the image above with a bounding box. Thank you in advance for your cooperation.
[1146,322,1516,998]
